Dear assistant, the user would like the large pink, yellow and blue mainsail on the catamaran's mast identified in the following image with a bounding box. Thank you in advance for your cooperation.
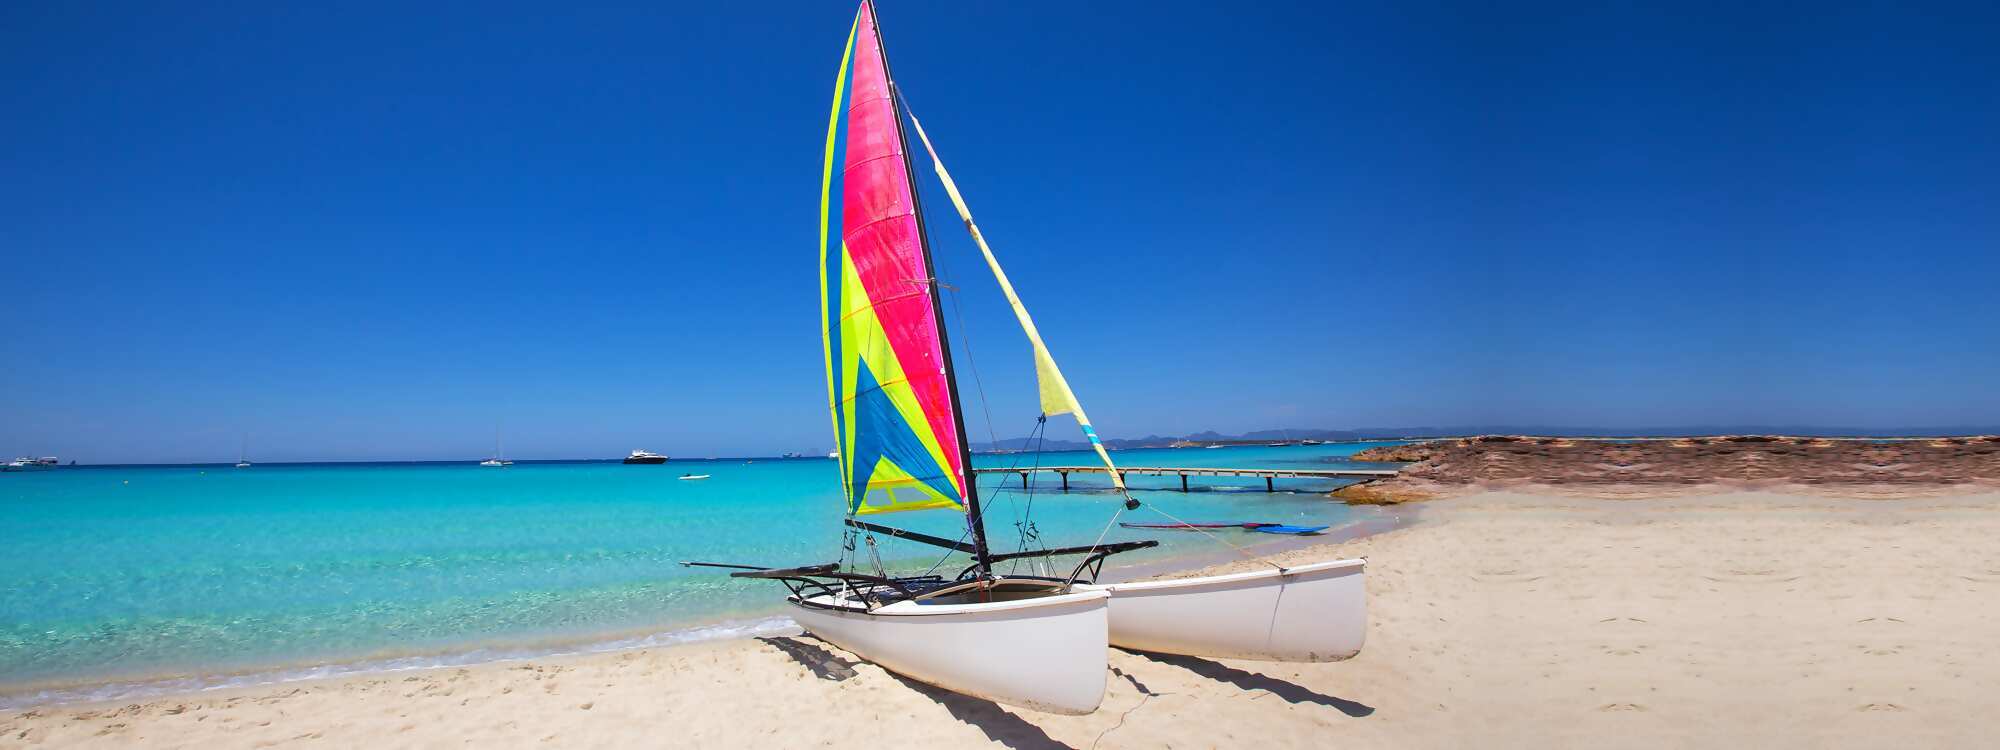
[820,2,966,514]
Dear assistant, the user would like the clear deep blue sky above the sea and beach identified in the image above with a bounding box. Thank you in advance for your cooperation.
[0,0,2000,462]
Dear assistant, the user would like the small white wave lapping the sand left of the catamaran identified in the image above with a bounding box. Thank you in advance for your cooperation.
[0,616,798,712]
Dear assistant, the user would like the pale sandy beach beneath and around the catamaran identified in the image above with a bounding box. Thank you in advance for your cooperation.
[0,492,2000,748]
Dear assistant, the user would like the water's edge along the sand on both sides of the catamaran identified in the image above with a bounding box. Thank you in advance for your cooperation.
[0,508,1420,714]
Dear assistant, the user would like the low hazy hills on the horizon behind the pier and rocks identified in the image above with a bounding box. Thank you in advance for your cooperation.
[972,424,2000,454]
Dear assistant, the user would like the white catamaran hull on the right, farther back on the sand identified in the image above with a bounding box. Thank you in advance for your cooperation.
[1078,560,1368,662]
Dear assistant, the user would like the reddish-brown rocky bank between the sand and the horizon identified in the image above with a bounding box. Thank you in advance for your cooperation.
[1332,434,2000,504]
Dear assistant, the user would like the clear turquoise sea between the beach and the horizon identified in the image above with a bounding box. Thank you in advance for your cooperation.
[0,444,1390,708]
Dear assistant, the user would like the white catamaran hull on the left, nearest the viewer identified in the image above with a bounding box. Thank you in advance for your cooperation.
[792,592,1110,714]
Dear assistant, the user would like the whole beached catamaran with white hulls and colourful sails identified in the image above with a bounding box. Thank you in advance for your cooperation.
[686,0,1366,714]
